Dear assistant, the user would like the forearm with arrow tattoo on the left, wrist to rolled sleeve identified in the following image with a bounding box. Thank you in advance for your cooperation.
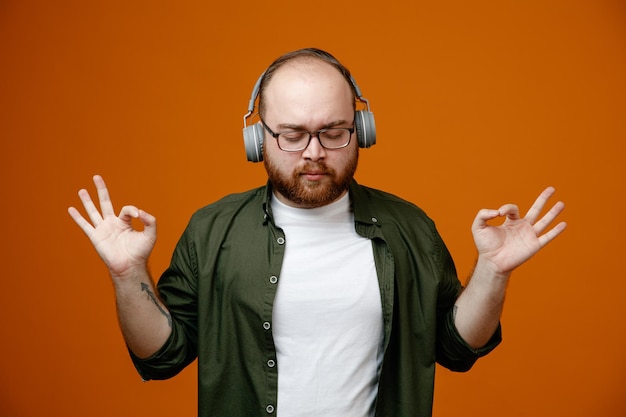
[112,268,172,358]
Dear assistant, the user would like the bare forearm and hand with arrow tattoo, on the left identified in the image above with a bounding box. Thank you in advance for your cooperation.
[68,175,171,358]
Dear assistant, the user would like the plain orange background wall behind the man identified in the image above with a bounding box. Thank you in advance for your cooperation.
[0,0,626,417]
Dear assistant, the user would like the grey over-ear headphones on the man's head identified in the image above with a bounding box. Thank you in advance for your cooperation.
[243,73,376,162]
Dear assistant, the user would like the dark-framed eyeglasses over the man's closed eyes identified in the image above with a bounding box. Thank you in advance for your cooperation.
[261,120,354,152]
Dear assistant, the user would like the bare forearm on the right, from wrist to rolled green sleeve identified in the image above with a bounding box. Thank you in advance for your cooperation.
[454,259,509,349]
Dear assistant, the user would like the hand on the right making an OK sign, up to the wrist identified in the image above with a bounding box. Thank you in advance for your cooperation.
[472,187,567,275]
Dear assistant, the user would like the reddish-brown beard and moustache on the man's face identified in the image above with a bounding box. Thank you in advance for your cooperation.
[263,148,359,208]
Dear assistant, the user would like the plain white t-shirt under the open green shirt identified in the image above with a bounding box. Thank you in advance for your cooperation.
[271,194,383,417]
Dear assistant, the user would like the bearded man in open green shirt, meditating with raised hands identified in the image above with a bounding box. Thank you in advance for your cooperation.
[69,49,565,417]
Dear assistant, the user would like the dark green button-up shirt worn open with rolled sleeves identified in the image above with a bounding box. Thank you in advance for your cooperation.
[131,182,501,417]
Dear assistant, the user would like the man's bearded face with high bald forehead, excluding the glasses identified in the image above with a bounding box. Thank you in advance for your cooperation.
[263,60,358,208]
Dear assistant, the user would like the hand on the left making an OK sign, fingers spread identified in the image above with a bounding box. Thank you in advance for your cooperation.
[68,175,157,279]
